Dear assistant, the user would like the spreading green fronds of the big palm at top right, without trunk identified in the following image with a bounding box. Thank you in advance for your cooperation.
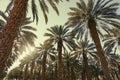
[66,0,120,32]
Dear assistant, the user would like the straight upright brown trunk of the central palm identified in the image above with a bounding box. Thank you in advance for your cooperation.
[57,39,62,80]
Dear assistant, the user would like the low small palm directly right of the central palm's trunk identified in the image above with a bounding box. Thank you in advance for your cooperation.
[63,51,82,80]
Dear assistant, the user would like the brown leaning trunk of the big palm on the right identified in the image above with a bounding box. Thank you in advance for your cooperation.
[88,19,111,80]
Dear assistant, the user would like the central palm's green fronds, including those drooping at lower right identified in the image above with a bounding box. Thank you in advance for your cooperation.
[44,25,76,53]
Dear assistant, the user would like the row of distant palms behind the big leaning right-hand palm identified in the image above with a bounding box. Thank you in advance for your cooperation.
[4,26,120,80]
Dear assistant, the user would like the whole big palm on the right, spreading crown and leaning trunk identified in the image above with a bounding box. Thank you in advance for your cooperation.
[66,0,120,80]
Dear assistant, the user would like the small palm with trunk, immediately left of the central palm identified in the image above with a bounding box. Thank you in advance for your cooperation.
[37,40,56,80]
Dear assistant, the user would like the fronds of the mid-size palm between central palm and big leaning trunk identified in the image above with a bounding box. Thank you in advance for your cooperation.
[75,35,99,60]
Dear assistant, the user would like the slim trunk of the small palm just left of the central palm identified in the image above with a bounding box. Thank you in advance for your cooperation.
[41,51,47,80]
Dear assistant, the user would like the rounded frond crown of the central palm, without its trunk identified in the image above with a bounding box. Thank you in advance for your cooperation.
[45,25,72,45]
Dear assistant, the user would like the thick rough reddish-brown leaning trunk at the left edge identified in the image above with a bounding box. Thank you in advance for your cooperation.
[0,0,28,72]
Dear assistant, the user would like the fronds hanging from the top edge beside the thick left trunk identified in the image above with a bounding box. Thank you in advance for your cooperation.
[5,0,69,23]
